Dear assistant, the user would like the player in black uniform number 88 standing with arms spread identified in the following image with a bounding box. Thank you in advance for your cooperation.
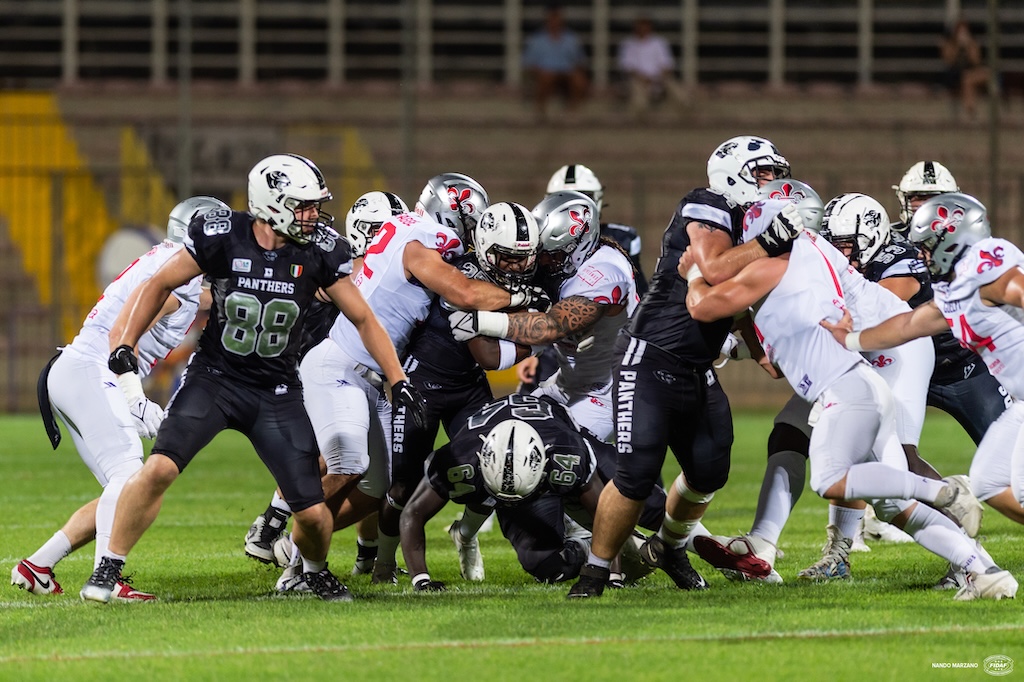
[81,155,419,602]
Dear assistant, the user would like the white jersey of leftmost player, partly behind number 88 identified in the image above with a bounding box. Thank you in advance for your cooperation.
[71,240,203,377]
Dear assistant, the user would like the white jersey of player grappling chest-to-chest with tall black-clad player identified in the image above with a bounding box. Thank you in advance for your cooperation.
[754,231,878,401]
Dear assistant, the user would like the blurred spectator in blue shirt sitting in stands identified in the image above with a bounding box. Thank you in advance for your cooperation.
[522,5,589,121]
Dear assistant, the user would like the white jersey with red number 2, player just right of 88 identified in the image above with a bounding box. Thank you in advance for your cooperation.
[330,213,465,373]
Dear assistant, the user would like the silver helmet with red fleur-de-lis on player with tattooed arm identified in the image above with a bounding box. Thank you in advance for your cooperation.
[534,191,601,280]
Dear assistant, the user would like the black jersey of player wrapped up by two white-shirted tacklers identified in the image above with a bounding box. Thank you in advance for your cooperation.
[406,253,490,375]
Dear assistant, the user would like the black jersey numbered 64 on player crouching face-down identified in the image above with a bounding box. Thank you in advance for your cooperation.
[427,393,597,507]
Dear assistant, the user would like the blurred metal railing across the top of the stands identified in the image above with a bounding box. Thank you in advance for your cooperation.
[0,0,1024,88]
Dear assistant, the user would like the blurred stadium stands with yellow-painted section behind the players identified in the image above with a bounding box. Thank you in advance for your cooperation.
[0,0,1024,412]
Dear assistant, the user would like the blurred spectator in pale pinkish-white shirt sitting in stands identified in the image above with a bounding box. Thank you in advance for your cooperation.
[618,16,686,117]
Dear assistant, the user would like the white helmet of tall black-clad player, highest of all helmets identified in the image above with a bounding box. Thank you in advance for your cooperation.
[708,135,790,207]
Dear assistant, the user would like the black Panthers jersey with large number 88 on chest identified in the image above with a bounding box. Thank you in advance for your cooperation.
[185,210,352,388]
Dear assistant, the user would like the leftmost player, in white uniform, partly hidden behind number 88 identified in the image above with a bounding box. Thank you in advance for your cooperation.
[10,197,227,601]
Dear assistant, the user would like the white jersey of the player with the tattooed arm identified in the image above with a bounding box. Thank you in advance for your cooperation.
[556,244,640,395]
